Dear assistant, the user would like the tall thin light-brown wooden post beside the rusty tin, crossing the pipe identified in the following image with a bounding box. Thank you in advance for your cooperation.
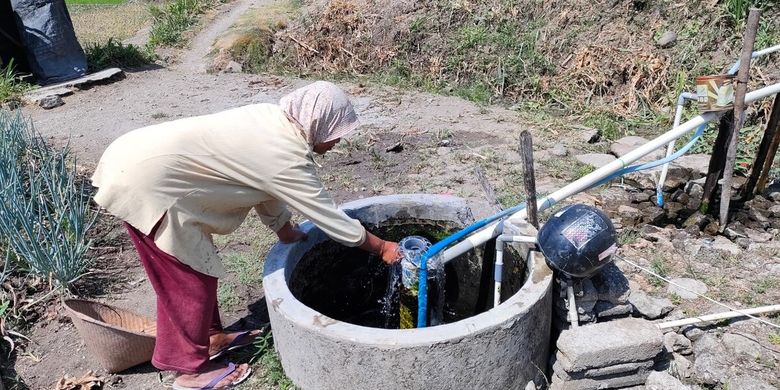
[720,8,761,232]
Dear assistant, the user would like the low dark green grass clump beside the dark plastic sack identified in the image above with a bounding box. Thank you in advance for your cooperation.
[85,38,154,72]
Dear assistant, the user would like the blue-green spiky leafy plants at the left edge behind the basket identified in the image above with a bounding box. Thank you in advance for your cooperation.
[0,111,98,287]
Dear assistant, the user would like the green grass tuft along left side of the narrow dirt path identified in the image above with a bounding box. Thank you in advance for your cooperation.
[148,0,213,47]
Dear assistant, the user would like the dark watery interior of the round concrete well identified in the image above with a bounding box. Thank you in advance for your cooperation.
[289,221,524,329]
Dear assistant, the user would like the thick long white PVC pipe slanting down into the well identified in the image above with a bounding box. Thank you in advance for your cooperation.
[441,83,780,263]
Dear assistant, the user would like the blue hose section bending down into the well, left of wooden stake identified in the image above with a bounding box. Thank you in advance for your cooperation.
[417,202,525,328]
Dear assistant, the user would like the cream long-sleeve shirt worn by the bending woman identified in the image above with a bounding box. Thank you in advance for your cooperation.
[92,104,366,277]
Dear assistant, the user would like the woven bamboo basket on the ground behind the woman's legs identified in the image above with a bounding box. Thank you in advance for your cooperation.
[64,299,157,372]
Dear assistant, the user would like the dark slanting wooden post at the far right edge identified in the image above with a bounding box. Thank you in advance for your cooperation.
[742,95,780,199]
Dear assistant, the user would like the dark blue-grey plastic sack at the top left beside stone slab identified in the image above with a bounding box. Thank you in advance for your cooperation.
[11,0,87,84]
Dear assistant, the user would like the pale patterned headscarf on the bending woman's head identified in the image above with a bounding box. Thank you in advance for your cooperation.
[279,81,359,146]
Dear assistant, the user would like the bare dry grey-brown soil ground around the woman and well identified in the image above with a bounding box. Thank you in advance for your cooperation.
[7,0,780,389]
